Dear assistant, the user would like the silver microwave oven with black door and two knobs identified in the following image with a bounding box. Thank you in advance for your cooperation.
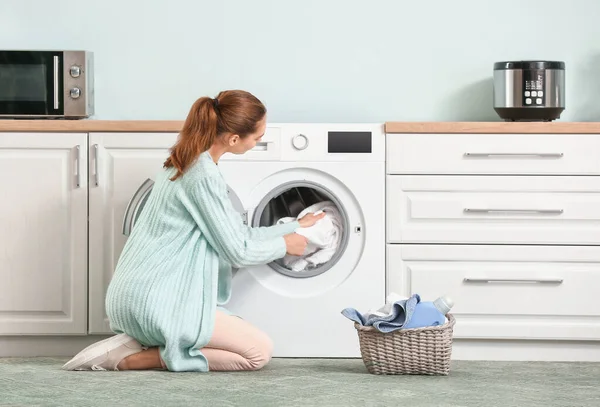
[0,50,94,119]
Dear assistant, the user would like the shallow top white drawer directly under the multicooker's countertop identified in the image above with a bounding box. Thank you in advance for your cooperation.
[386,134,600,175]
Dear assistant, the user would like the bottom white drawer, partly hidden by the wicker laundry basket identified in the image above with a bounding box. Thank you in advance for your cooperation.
[387,245,600,340]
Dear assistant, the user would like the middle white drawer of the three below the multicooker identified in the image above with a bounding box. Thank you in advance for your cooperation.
[386,175,600,245]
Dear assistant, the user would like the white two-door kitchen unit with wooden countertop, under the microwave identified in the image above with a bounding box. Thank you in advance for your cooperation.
[0,120,181,356]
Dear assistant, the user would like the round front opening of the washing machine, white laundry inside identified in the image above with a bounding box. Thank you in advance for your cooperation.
[244,168,365,297]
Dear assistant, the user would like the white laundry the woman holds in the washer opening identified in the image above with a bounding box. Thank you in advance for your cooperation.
[277,201,343,272]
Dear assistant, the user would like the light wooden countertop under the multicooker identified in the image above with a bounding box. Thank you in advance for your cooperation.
[385,121,600,134]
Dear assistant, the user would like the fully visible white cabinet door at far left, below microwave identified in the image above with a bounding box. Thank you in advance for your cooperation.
[0,133,87,335]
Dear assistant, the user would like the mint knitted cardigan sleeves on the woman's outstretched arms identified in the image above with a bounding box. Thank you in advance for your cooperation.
[188,176,299,267]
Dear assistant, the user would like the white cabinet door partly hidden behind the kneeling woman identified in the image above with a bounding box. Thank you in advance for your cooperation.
[89,133,177,334]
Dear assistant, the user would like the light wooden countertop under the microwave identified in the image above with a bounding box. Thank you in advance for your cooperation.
[0,119,183,133]
